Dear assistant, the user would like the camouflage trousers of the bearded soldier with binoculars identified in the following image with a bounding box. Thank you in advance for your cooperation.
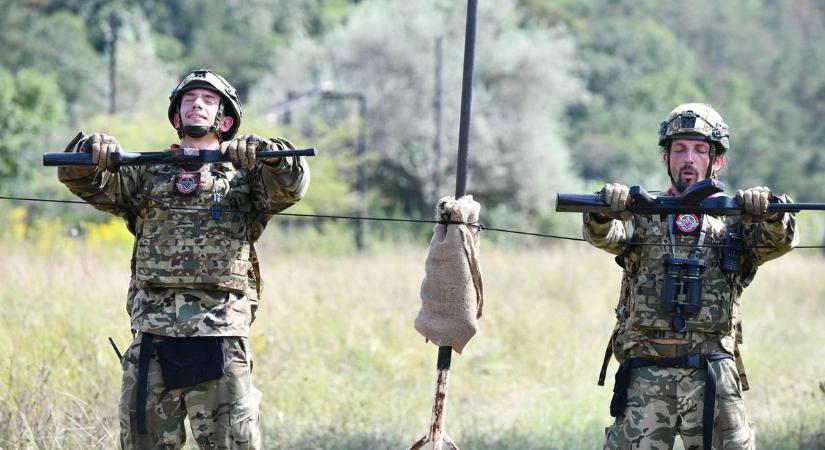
[604,359,755,450]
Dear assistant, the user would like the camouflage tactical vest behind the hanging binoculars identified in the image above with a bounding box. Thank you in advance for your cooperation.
[625,216,740,334]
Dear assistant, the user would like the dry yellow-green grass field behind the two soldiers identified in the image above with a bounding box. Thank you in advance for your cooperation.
[0,236,825,450]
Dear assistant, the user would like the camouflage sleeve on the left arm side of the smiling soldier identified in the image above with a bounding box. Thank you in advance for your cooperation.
[57,132,141,218]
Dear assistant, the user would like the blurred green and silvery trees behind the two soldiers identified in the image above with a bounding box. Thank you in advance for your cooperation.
[0,0,825,232]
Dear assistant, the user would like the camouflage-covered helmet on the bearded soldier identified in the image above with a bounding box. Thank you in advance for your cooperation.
[659,103,730,155]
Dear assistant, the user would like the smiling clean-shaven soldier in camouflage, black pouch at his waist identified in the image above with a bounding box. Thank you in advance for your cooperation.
[58,69,309,449]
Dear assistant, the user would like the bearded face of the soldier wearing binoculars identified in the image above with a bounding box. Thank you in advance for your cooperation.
[664,139,725,192]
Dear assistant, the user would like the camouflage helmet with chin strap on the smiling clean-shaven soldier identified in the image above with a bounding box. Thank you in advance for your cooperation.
[167,69,243,141]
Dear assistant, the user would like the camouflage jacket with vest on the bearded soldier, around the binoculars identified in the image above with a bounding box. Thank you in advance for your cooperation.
[583,196,799,361]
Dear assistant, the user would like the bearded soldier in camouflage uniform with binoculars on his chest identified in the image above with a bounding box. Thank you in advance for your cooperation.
[583,103,798,450]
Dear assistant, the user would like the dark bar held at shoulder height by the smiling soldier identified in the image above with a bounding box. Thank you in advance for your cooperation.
[43,147,318,166]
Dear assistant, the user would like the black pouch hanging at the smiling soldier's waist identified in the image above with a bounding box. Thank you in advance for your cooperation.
[157,336,223,389]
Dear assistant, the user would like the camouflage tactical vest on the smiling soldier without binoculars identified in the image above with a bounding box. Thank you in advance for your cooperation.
[134,164,252,293]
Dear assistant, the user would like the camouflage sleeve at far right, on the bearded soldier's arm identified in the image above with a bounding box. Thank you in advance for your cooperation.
[743,195,799,266]
